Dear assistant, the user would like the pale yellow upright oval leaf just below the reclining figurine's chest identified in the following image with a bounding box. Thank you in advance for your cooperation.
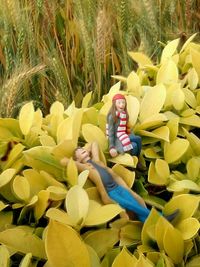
[65,185,89,224]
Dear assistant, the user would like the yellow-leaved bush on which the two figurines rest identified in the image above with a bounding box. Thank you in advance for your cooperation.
[0,35,200,267]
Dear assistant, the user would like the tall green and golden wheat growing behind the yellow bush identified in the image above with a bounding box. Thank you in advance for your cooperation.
[0,0,200,116]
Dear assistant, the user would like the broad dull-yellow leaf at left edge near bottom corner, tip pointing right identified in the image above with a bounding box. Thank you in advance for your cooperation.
[0,227,46,259]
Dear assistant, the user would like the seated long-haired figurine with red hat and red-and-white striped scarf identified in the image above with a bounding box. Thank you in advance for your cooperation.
[106,94,142,157]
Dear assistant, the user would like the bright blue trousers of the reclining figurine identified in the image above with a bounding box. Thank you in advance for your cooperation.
[108,185,150,222]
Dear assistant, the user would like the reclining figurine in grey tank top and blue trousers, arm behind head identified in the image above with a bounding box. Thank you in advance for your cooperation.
[61,142,177,222]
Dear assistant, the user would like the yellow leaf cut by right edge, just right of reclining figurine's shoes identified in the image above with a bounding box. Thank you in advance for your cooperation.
[176,218,200,240]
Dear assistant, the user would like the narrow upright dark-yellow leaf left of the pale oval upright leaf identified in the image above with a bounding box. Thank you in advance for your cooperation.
[34,190,49,221]
